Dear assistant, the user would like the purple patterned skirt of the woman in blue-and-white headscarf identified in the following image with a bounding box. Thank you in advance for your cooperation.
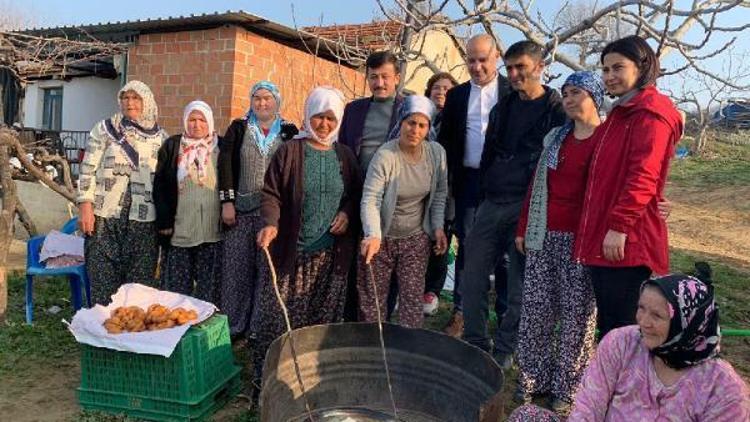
[219,214,266,336]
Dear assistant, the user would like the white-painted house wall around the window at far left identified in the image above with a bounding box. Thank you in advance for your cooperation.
[23,77,120,131]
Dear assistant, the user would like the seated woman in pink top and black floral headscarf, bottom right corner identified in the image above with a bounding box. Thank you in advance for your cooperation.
[509,263,750,422]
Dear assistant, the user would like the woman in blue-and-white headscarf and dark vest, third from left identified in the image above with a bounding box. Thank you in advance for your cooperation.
[219,81,298,337]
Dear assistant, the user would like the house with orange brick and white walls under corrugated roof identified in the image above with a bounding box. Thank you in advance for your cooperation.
[17,11,367,133]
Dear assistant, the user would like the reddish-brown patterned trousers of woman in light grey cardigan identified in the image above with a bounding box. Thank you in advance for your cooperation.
[357,232,431,328]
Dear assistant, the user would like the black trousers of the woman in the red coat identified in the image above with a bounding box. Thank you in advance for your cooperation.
[589,266,651,339]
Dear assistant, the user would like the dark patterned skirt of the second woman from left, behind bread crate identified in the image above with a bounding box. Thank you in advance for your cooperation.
[161,242,221,304]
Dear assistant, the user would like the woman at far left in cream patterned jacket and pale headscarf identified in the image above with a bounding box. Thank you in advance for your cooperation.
[76,81,166,304]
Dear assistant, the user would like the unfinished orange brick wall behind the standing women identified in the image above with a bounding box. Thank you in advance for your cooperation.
[128,25,367,134]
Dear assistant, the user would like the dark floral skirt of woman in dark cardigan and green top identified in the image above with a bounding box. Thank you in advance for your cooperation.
[248,248,347,382]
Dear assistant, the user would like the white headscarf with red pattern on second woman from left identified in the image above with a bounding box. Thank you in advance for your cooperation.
[177,101,218,186]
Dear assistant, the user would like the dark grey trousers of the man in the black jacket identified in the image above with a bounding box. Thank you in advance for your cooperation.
[461,200,525,354]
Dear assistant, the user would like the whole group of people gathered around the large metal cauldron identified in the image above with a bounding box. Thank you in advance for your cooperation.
[73,34,750,420]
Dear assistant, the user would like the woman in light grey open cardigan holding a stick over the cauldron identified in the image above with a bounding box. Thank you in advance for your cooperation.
[357,95,448,328]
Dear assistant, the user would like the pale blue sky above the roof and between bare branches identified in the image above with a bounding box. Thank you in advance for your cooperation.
[5,0,750,106]
